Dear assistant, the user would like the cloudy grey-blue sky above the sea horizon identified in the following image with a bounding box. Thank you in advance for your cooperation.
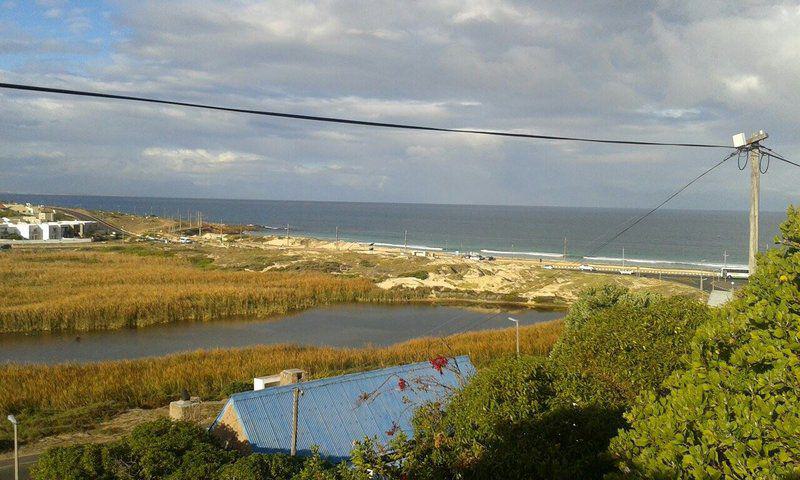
[0,0,800,210]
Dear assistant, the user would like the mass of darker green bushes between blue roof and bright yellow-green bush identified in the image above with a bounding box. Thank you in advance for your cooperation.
[354,286,710,480]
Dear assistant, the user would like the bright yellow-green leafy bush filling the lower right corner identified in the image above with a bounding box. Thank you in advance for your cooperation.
[611,207,800,479]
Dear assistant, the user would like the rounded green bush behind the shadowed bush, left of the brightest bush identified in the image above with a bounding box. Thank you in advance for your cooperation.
[550,285,711,409]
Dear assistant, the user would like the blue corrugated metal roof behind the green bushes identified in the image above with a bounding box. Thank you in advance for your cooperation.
[223,356,475,461]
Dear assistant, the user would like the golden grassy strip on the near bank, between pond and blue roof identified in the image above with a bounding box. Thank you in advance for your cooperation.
[0,321,562,450]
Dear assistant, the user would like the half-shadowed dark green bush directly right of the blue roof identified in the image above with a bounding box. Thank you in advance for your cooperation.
[353,357,619,480]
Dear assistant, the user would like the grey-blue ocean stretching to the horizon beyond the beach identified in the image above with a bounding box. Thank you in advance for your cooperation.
[0,194,785,268]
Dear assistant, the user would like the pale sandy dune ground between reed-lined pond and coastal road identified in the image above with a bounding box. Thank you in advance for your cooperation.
[184,234,704,307]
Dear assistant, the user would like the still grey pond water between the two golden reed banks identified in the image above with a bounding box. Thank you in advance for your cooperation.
[0,305,564,363]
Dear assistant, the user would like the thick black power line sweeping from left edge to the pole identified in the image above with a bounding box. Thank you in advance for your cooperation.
[0,83,732,148]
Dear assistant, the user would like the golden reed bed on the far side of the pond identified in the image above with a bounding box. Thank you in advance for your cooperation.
[0,251,396,333]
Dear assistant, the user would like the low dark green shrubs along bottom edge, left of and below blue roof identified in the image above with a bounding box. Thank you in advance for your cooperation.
[31,419,360,480]
